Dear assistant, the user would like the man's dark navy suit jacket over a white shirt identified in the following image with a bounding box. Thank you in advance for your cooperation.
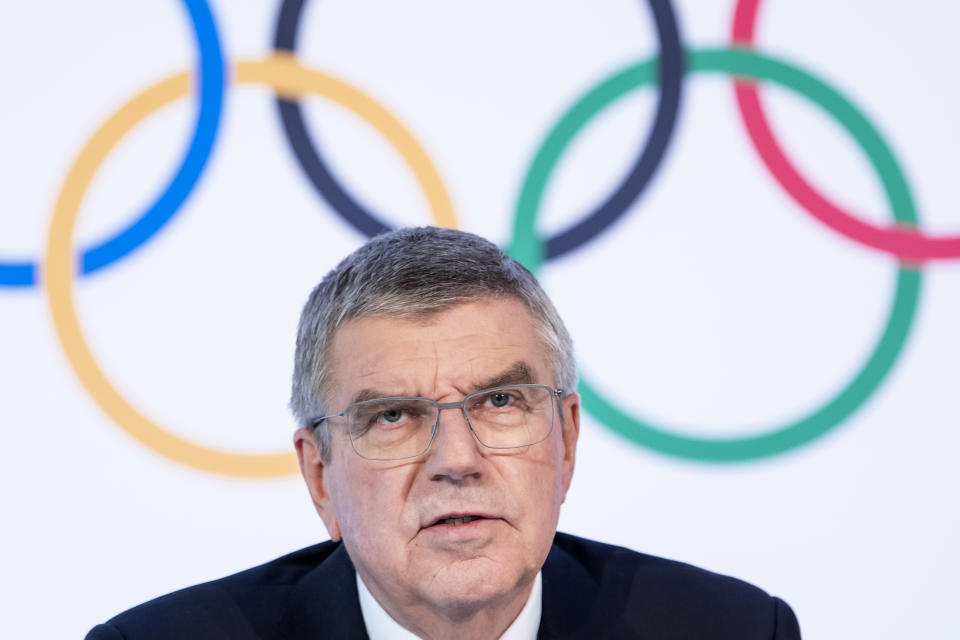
[87,533,800,640]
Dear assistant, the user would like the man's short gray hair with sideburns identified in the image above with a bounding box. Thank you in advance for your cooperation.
[290,227,577,459]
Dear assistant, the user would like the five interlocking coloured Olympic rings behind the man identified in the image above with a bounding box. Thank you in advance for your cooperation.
[0,0,960,477]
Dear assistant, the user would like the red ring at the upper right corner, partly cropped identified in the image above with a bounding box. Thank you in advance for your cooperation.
[731,0,960,262]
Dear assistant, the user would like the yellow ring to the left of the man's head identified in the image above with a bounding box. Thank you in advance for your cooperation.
[43,54,456,477]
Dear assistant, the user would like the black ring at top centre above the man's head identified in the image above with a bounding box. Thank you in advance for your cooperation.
[273,0,684,260]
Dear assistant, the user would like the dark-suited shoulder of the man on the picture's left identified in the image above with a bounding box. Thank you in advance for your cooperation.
[87,542,352,640]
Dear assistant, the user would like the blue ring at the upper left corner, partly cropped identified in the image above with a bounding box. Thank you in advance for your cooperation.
[0,0,224,287]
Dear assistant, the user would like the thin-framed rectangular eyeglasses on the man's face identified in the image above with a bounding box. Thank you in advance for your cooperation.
[310,384,563,460]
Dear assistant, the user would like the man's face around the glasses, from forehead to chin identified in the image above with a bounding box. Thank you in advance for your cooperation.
[296,298,579,619]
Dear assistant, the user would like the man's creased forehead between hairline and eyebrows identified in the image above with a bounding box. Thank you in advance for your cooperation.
[330,298,555,404]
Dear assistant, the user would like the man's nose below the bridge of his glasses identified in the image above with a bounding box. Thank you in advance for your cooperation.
[425,408,483,483]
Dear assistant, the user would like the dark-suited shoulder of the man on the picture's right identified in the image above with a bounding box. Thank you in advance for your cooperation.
[544,533,800,640]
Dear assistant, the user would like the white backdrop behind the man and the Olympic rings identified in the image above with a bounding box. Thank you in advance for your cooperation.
[0,0,960,638]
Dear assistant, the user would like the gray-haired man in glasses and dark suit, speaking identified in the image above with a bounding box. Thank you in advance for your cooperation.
[88,228,800,640]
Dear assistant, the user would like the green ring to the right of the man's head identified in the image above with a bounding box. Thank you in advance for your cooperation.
[510,49,921,462]
